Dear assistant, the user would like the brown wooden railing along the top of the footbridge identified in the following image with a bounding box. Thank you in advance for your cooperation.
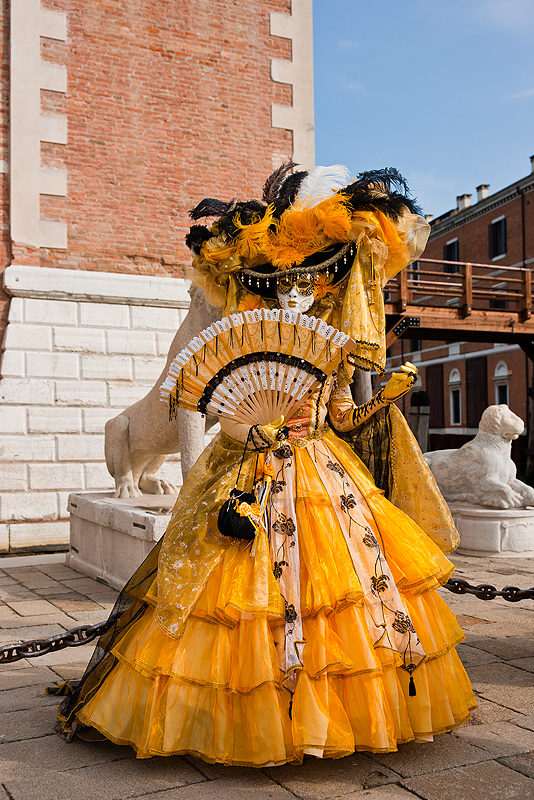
[384,258,532,322]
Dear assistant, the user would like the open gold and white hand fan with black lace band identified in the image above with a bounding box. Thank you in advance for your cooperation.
[160,308,355,425]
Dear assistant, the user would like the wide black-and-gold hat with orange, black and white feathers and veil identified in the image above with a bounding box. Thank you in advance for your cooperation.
[186,161,429,371]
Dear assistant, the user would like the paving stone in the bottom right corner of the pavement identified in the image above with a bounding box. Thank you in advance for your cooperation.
[404,756,534,800]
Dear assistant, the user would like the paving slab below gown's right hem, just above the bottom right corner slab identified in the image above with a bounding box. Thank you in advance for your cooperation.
[369,733,492,780]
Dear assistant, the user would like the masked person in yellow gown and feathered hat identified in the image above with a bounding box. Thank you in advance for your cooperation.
[54,163,476,767]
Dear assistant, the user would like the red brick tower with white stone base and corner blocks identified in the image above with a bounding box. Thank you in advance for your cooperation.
[0,0,314,552]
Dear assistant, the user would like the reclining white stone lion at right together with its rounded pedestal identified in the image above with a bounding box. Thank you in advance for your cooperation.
[424,405,534,557]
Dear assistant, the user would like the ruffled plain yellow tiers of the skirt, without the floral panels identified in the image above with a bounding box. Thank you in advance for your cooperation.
[77,435,476,767]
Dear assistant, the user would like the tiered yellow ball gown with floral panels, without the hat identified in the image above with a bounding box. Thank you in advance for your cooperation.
[60,378,476,767]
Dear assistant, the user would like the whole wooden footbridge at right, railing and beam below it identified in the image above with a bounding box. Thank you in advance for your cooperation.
[384,258,534,358]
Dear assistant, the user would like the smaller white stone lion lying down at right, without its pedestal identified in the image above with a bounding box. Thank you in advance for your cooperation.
[430,404,534,508]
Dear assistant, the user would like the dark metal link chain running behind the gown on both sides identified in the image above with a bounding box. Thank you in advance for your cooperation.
[0,578,534,664]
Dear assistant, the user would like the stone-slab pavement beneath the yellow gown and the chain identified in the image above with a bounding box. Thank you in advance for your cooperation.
[0,556,534,800]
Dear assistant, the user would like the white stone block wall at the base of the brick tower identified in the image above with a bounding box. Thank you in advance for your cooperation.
[0,266,193,552]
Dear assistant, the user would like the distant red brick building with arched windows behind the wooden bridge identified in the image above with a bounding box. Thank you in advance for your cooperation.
[388,157,534,468]
